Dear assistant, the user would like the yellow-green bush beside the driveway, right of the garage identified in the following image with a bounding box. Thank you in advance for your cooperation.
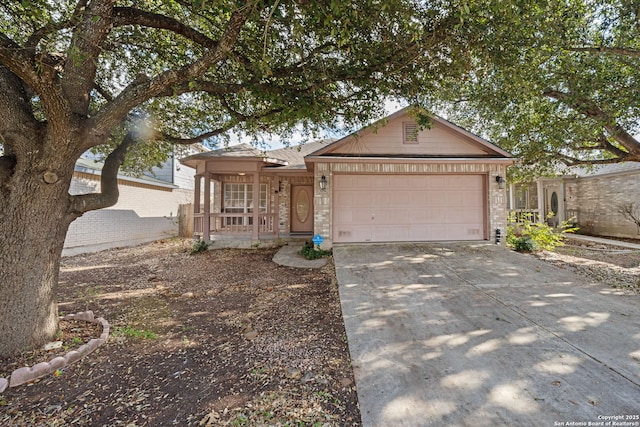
[507,214,578,252]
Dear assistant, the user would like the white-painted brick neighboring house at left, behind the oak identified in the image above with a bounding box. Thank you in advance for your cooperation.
[63,145,204,255]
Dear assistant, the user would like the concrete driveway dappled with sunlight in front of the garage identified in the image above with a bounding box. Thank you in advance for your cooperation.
[334,243,640,427]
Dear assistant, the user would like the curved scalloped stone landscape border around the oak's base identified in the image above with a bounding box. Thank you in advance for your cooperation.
[0,310,111,393]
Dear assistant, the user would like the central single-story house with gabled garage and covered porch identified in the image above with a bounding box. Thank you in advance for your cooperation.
[181,109,514,247]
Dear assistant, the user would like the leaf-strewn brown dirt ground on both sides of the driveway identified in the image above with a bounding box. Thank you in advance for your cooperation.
[0,236,640,426]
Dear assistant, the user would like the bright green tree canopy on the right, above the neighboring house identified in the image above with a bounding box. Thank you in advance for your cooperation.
[429,0,640,180]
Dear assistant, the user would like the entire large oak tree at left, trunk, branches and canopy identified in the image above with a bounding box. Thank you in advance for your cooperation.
[0,0,476,356]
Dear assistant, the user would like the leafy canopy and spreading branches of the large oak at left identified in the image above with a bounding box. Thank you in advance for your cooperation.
[0,0,472,178]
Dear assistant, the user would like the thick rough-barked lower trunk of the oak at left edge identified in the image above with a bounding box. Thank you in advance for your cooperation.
[0,156,75,357]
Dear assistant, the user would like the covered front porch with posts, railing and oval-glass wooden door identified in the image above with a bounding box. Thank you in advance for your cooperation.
[182,144,314,246]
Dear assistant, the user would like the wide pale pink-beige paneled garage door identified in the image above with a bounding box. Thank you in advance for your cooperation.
[333,175,486,242]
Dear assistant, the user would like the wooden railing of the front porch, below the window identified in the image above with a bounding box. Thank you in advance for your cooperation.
[193,213,275,235]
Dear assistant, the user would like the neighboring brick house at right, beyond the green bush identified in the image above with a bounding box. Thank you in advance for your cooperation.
[508,162,640,238]
